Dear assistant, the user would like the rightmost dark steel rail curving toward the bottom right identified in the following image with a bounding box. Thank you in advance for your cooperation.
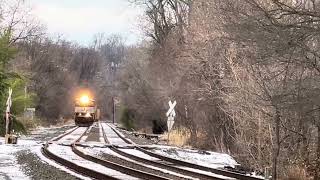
[108,125,261,180]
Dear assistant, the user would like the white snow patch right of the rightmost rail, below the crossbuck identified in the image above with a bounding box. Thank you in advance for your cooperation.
[154,146,239,168]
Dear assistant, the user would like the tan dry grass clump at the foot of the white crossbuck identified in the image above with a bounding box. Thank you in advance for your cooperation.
[162,128,190,147]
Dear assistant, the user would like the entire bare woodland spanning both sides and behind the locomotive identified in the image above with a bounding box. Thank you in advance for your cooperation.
[0,0,320,179]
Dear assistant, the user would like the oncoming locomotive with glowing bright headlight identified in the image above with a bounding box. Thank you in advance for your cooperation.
[74,94,100,126]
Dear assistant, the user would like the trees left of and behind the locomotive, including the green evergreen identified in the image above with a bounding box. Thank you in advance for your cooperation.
[0,0,127,125]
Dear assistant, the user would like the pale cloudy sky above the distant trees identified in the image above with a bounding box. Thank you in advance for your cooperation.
[29,0,143,45]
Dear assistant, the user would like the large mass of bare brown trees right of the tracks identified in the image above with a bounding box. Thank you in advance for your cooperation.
[119,0,320,179]
